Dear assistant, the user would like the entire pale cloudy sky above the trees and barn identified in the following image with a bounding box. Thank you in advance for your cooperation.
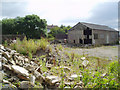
[0,0,119,29]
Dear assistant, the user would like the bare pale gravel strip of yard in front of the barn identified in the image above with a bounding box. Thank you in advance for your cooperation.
[65,45,118,60]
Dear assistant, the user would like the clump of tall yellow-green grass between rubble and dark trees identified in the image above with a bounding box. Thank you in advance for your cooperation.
[10,37,50,56]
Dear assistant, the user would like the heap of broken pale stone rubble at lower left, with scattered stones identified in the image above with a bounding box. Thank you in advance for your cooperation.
[0,44,83,89]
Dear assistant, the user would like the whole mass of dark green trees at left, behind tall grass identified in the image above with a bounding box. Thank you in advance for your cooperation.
[0,14,47,38]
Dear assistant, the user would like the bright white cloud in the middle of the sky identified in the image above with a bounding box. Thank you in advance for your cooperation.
[28,0,102,25]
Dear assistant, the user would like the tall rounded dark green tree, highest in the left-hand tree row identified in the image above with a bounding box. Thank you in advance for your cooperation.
[24,15,47,38]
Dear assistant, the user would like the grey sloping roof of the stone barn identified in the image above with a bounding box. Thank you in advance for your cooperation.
[80,22,117,31]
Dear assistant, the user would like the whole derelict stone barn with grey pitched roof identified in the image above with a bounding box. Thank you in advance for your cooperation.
[68,22,119,45]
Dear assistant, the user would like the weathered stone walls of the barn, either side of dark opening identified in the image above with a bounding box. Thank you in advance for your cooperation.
[68,28,118,45]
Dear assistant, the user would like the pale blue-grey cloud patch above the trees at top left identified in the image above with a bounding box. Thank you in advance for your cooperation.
[2,2,27,18]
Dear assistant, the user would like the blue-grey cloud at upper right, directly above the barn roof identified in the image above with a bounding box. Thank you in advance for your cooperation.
[86,2,118,28]
